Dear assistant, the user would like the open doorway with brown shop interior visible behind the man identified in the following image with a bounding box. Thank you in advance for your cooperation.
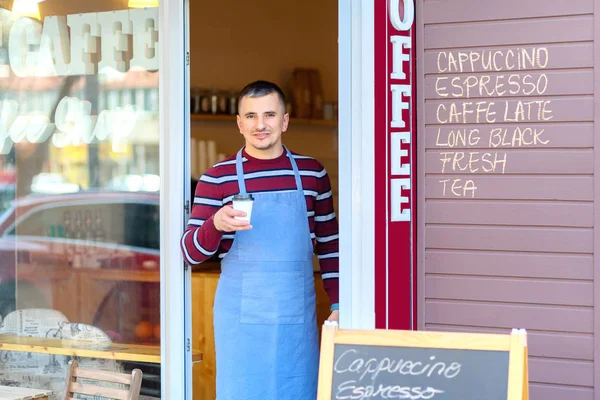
[189,0,339,400]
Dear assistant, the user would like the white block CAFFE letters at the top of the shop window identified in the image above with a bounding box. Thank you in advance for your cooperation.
[0,7,159,78]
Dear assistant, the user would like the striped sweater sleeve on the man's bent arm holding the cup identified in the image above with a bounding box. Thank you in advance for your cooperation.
[181,168,223,265]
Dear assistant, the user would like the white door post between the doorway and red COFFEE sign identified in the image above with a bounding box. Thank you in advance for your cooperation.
[338,0,379,329]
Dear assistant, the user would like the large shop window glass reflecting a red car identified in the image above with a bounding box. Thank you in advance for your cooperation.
[0,0,160,400]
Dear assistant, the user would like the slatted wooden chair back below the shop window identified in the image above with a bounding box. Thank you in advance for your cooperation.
[64,360,142,400]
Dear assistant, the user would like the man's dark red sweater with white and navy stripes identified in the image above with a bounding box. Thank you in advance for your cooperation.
[181,151,339,304]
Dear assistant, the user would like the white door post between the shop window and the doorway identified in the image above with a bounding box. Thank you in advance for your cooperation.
[159,0,192,400]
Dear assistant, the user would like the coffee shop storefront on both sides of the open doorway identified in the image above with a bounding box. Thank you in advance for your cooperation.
[0,0,600,400]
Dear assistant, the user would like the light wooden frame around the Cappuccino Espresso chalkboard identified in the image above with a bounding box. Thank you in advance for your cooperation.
[317,321,529,400]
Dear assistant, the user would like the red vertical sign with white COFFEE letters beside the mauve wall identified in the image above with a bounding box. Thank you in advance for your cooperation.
[374,0,416,329]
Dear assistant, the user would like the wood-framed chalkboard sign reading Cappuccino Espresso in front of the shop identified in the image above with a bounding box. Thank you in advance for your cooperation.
[318,324,529,400]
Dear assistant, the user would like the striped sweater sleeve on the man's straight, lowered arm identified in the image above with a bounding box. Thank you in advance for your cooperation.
[314,164,339,309]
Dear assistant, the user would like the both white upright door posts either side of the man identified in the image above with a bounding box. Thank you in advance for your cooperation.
[159,0,375,399]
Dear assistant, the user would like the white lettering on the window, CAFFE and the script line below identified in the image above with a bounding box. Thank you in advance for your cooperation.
[0,7,159,154]
